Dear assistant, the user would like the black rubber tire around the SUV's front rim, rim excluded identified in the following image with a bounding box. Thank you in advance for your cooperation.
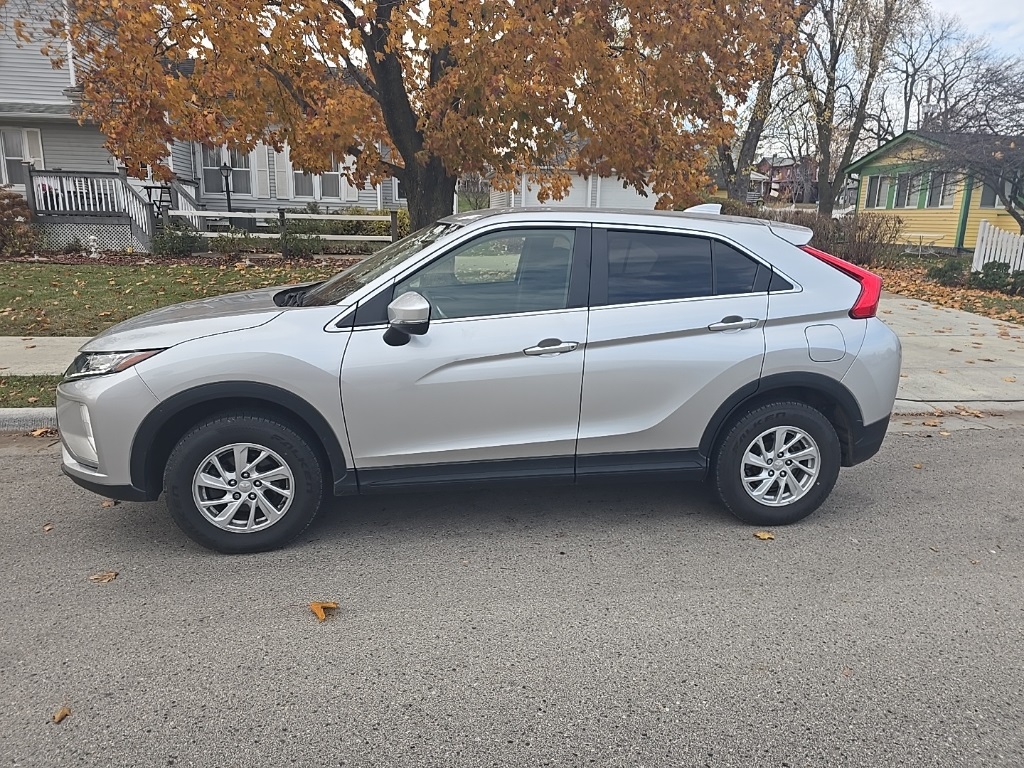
[164,412,324,554]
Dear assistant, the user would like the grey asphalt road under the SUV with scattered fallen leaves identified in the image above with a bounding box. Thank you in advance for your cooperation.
[0,429,1024,768]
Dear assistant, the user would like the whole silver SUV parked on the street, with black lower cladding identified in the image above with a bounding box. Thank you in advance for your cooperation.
[57,208,900,552]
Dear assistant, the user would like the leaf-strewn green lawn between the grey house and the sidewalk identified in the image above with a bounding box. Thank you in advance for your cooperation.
[0,261,345,336]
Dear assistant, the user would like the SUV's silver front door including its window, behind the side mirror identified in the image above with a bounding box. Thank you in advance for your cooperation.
[341,226,591,489]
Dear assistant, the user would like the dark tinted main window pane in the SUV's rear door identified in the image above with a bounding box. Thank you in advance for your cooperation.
[608,231,712,304]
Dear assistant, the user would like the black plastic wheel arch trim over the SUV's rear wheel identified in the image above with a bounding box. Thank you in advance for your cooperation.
[699,372,864,467]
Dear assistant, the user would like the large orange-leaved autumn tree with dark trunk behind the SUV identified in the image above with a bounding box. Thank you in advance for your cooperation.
[9,0,796,225]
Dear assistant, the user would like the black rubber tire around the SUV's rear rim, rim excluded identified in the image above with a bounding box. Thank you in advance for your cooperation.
[712,401,842,525]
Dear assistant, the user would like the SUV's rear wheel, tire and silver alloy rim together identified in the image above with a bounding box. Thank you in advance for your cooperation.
[713,401,842,525]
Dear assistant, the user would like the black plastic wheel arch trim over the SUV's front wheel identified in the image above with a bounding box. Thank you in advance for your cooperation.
[130,381,354,501]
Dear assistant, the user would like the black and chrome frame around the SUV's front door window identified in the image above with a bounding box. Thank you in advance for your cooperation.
[350,221,593,330]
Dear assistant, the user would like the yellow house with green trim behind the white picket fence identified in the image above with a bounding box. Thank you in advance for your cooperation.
[844,131,1020,250]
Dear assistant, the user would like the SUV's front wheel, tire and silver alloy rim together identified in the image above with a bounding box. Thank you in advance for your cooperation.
[164,412,324,554]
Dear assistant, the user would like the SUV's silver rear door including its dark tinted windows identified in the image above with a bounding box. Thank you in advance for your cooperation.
[577,228,771,476]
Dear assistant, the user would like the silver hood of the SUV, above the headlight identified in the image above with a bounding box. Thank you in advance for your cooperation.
[82,286,284,352]
